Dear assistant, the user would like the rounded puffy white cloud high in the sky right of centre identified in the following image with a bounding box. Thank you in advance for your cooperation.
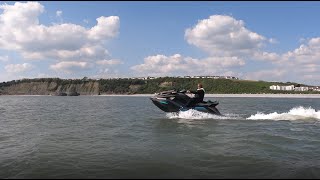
[185,15,268,56]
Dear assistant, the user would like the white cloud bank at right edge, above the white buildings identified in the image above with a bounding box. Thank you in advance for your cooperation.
[241,37,320,84]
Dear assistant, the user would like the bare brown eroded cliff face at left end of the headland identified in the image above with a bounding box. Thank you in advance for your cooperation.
[1,82,99,95]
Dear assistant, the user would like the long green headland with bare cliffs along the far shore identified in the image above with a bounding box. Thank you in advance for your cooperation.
[0,77,319,95]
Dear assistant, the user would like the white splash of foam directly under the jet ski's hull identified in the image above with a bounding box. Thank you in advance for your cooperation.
[166,109,235,119]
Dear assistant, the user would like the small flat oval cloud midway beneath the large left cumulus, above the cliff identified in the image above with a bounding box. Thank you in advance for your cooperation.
[50,61,92,73]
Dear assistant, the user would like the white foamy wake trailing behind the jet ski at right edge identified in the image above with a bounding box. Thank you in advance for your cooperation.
[247,106,320,120]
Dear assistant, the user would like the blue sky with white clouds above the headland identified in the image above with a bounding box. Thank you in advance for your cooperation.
[0,1,320,85]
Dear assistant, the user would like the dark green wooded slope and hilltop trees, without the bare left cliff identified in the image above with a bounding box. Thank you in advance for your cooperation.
[0,77,318,94]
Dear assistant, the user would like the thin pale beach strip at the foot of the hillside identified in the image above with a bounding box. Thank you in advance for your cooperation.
[0,94,320,98]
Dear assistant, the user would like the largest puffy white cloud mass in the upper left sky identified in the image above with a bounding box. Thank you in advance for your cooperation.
[0,2,120,74]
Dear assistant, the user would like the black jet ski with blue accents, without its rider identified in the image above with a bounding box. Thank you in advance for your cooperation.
[150,90,221,115]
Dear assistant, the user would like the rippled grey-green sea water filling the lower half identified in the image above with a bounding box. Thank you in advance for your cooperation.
[0,96,320,178]
